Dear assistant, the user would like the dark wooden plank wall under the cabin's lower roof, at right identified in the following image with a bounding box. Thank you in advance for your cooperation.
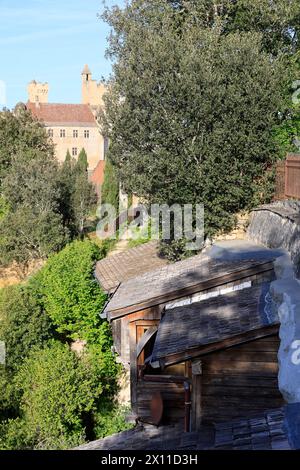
[199,335,284,422]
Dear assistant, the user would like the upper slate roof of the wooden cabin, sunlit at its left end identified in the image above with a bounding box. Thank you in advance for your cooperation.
[105,254,272,319]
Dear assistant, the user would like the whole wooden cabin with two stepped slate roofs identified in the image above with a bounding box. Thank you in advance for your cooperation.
[99,246,283,429]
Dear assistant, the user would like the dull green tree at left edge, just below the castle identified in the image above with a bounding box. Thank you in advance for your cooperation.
[0,108,69,268]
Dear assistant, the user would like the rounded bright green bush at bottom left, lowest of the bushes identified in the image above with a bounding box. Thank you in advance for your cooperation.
[10,342,103,449]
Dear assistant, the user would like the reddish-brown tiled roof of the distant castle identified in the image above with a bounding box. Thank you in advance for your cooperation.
[26,102,97,127]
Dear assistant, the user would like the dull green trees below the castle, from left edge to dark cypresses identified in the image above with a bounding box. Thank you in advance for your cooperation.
[0,106,97,267]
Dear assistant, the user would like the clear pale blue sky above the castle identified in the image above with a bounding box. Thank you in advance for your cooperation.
[0,0,125,108]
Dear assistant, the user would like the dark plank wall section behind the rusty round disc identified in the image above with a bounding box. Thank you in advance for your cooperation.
[137,380,184,423]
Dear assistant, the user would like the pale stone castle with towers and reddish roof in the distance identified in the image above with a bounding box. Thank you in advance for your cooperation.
[26,65,108,192]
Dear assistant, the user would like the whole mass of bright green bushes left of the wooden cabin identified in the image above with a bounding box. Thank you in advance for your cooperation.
[0,241,127,449]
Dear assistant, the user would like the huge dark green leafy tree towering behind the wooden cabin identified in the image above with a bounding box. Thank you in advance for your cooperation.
[102,0,285,239]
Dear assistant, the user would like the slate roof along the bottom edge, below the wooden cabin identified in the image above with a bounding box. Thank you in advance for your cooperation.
[77,408,291,450]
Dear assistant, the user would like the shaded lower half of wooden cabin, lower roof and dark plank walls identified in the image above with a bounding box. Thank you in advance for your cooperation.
[146,283,284,430]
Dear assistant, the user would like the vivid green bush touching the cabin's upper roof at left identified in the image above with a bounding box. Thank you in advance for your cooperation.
[37,241,110,346]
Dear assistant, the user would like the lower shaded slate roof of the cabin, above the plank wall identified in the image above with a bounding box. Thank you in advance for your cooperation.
[152,283,279,362]
